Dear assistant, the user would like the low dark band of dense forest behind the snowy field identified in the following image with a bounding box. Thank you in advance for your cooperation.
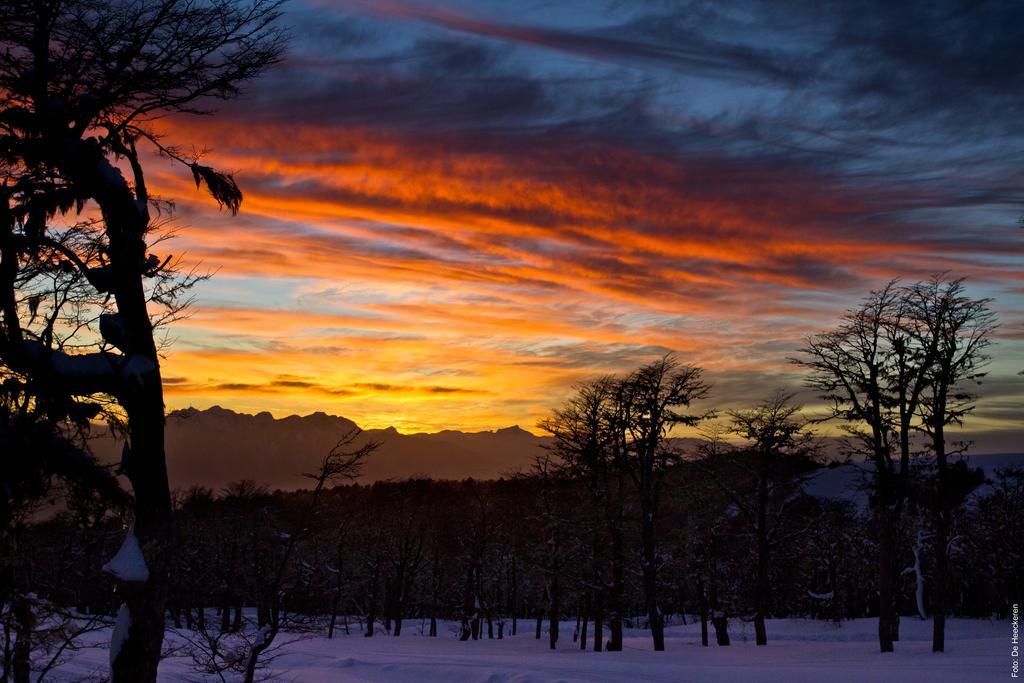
[3,385,1024,681]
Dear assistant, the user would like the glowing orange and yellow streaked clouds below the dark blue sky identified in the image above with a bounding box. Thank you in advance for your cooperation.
[128,114,1020,429]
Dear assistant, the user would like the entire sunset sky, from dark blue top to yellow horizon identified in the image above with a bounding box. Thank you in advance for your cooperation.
[150,0,1024,450]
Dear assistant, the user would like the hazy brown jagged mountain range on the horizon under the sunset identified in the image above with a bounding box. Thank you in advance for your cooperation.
[93,405,548,489]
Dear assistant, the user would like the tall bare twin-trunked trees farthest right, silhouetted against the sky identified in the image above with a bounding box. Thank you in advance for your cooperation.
[797,278,995,652]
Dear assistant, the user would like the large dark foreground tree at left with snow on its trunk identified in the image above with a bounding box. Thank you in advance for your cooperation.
[0,0,284,681]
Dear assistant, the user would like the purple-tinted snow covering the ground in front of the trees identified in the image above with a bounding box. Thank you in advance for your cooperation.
[52,617,1010,683]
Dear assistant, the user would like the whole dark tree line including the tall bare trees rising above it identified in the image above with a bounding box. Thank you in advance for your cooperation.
[2,278,1024,683]
